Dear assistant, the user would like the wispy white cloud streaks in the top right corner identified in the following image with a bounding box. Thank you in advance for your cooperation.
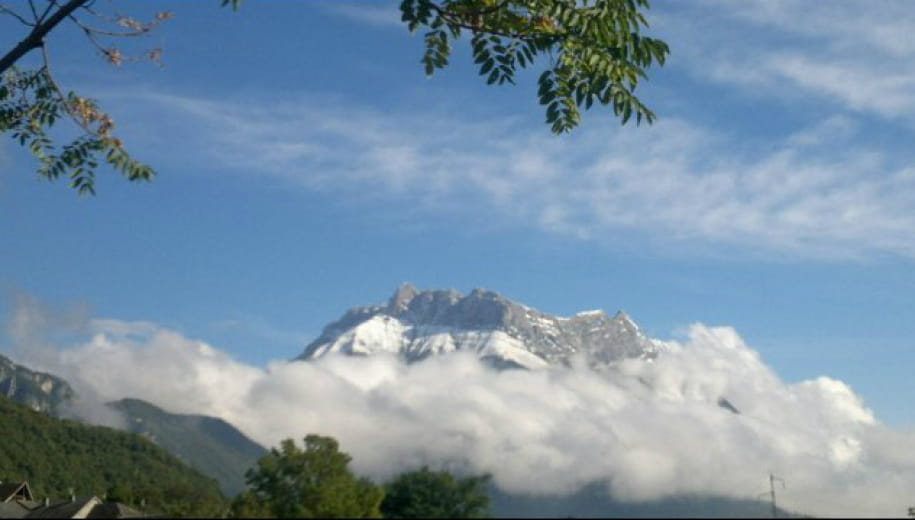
[662,1,915,122]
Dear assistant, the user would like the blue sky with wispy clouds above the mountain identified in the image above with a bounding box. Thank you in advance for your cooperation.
[0,0,915,425]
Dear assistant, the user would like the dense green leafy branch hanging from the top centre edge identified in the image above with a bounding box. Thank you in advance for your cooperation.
[400,0,670,134]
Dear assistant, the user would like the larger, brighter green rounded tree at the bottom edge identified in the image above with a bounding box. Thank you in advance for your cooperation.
[233,434,384,518]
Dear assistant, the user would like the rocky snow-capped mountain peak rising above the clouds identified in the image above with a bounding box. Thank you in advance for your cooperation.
[297,284,662,369]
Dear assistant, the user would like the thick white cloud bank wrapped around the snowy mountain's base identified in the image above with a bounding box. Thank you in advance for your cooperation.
[11,294,915,516]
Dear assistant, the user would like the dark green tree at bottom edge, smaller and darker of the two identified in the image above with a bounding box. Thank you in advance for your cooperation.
[381,467,489,518]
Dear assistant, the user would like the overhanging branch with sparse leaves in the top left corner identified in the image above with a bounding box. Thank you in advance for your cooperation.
[0,0,163,195]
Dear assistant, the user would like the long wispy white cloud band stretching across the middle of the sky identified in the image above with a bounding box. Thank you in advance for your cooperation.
[107,89,915,258]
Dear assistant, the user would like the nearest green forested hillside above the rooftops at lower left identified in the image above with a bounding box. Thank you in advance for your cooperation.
[0,396,227,517]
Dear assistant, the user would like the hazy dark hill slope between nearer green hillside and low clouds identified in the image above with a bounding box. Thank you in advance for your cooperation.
[110,399,267,495]
